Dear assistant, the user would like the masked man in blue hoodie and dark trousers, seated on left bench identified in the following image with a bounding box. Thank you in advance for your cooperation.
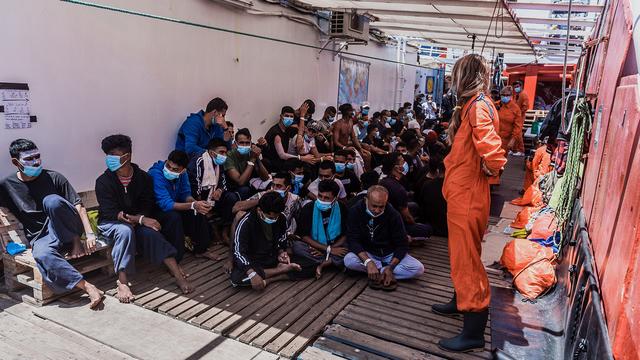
[149,150,215,262]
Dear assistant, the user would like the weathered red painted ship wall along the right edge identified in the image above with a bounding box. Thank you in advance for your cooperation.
[581,0,640,359]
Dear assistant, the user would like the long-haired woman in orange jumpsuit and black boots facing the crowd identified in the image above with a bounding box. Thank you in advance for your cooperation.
[432,54,507,352]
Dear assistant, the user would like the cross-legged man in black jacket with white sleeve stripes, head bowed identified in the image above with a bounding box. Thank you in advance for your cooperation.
[231,191,301,290]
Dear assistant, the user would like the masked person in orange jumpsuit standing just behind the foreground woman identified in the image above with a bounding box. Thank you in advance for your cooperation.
[496,86,523,152]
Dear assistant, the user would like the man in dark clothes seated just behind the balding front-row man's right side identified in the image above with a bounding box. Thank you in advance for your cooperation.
[380,152,432,238]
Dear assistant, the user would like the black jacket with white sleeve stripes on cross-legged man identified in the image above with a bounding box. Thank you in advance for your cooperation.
[233,209,287,273]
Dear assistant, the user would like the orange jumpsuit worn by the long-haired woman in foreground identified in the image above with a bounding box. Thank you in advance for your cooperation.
[442,94,507,312]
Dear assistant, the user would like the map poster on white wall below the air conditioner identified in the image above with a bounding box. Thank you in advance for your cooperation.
[338,57,370,108]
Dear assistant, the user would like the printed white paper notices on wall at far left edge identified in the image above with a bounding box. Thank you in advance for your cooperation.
[0,82,36,129]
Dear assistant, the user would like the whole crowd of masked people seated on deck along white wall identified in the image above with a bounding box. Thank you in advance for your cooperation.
[0,94,448,307]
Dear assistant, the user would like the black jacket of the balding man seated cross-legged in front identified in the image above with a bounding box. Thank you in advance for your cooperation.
[347,199,409,260]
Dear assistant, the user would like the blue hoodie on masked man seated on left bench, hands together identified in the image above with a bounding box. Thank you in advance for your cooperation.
[149,161,191,212]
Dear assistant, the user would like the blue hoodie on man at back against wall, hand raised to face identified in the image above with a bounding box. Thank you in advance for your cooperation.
[176,110,224,158]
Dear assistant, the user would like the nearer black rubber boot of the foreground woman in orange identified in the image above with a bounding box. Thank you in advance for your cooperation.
[438,309,489,352]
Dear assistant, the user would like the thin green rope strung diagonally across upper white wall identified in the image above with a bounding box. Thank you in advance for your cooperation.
[60,0,426,69]
